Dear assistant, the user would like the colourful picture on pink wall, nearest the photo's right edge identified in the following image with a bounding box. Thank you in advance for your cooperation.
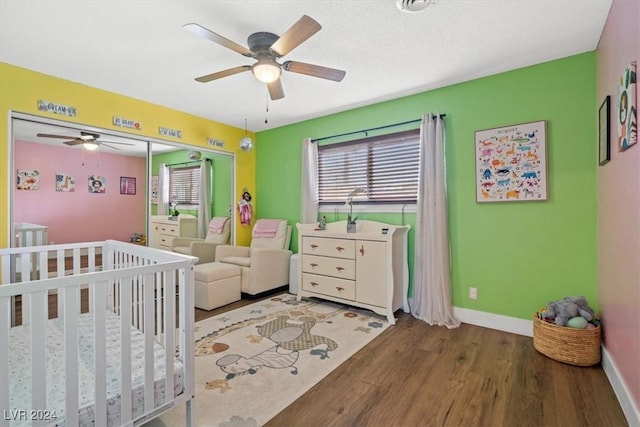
[616,62,638,151]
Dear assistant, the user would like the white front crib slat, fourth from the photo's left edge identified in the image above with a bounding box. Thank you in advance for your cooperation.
[91,282,107,426]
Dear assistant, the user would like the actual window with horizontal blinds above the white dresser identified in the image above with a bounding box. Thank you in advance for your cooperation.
[318,129,420,203]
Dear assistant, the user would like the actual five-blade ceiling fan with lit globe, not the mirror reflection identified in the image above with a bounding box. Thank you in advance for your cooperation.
[184,15,346,101]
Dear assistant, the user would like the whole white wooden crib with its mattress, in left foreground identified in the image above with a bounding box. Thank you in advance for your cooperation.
[0,240,197,427]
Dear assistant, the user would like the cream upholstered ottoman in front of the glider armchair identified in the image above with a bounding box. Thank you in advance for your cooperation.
[193,262,241,310]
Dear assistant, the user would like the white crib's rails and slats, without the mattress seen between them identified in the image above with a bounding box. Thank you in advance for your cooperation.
[0,240,196,426]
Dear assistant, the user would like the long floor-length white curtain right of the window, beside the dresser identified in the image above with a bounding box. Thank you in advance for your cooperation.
[409,113,460,328]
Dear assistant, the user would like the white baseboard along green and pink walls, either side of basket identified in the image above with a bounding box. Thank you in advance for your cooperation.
[453,307,640,427]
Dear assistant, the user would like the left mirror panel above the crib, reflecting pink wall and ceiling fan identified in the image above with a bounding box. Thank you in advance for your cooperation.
[10,118,147,246]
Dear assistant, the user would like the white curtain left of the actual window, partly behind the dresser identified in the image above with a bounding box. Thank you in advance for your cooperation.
[300,138,318,224]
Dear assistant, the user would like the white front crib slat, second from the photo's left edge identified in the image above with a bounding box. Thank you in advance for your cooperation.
[29,290,47,427]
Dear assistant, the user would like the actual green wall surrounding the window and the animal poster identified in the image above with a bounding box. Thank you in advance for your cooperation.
[256,52,597,319]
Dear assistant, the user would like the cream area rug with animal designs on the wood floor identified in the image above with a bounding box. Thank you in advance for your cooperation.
[146,294,389,427]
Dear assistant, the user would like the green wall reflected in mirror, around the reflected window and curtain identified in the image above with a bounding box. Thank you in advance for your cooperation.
[151,150,233,217]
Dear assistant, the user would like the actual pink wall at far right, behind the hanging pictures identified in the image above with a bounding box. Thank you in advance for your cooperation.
[594,0,640,411]
